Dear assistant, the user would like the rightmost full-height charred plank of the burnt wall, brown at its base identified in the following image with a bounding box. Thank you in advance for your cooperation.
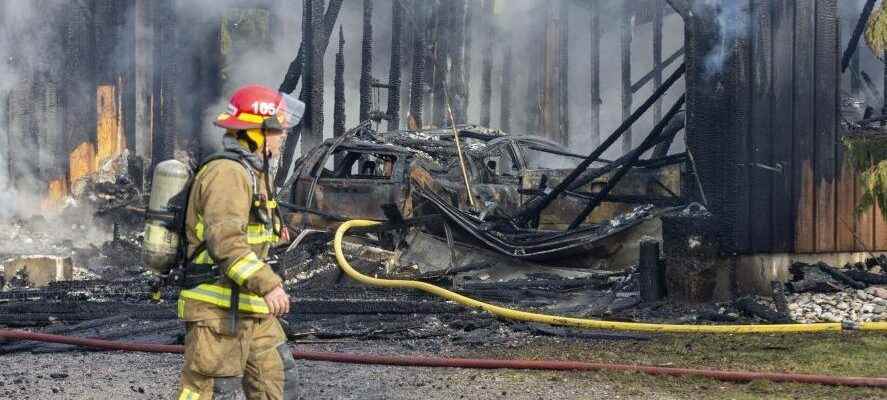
[814,0,840,252]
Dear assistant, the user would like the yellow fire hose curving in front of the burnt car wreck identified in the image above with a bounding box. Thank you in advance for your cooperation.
[333,220,887,333]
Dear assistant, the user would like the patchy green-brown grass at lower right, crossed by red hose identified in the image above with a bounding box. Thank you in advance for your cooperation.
[464,333,887,399]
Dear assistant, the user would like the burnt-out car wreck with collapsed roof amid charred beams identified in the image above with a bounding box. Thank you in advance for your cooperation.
[285,126,685,259]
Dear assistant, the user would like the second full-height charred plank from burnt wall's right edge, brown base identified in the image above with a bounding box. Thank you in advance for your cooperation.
[792,0,816,253]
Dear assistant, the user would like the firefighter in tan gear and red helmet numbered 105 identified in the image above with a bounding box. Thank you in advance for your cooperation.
[177,85,305,400]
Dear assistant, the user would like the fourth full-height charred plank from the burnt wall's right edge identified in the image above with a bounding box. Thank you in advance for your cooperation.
[745,0,775,253]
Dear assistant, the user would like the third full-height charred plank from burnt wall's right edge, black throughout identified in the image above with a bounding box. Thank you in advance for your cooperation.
[770,1,795,252]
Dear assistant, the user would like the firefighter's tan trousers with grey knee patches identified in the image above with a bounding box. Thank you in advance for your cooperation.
[177,317,297,400]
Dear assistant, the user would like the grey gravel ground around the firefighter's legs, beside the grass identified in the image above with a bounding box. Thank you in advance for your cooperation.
[0,342,670,400]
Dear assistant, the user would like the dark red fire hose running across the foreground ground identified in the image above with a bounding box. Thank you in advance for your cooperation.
[0,329,887,388]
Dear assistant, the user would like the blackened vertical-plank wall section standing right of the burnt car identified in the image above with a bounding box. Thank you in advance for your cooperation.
[676,0,856,254]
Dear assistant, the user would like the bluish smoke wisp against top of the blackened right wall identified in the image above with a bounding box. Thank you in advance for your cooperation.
[695,0,750,75]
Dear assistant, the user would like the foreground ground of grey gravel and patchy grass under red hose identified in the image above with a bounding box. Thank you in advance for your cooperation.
[0,334,887,400]
